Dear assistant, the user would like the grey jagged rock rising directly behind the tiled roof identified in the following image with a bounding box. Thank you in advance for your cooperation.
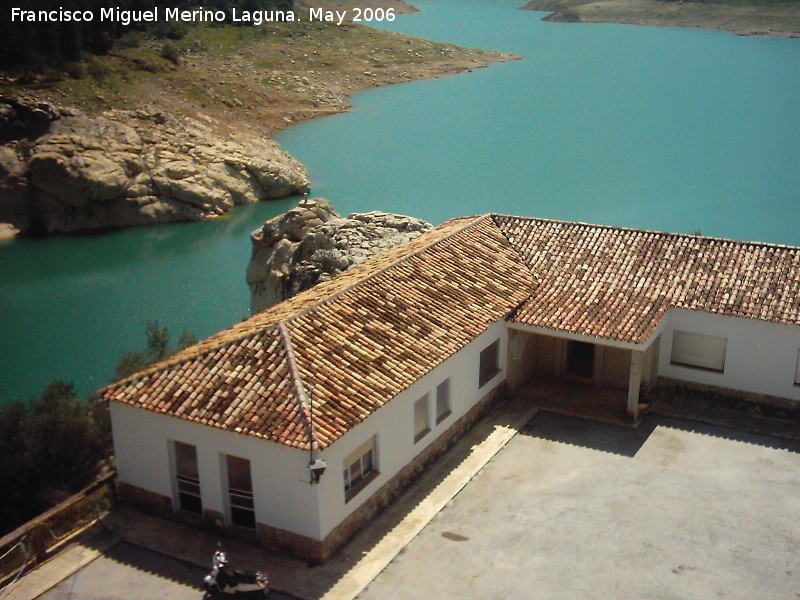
[247,198,432,314]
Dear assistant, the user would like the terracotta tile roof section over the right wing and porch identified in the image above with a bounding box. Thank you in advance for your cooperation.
[493,215,800,343]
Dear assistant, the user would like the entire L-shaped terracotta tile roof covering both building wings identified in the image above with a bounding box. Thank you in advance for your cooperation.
[101,215,800,449]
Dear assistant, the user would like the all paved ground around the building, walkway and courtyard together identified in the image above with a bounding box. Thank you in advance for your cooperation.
[7,386,800,599]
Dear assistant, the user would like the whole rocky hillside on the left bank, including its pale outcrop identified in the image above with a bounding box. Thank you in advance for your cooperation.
[0,8,518,238]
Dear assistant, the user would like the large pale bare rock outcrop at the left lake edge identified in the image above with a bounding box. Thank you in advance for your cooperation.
[0,98,309,233]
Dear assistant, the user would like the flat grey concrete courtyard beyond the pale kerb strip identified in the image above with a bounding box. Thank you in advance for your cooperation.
[360,413,800,600]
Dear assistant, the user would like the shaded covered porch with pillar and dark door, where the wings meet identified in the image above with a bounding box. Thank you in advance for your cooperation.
[507,324,660,424]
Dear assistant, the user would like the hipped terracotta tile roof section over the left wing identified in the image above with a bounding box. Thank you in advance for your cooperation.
[101,216,532,449]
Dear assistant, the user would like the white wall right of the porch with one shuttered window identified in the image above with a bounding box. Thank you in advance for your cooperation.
[658,309,800,400]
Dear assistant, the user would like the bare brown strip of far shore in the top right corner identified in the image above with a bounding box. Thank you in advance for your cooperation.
[522,0,800,38]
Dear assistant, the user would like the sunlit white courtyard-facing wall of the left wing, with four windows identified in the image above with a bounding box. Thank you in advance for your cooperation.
[316,321,508,537]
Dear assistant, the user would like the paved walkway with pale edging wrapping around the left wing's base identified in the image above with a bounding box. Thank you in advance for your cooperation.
[3,400,536,600]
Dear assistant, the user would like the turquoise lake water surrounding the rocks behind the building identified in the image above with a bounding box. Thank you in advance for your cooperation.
[0,0,800,402]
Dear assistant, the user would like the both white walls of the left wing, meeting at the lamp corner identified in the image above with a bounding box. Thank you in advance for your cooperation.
[111,322,508,540]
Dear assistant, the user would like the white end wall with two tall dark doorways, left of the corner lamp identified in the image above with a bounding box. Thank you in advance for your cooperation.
[111,402,322,539]
